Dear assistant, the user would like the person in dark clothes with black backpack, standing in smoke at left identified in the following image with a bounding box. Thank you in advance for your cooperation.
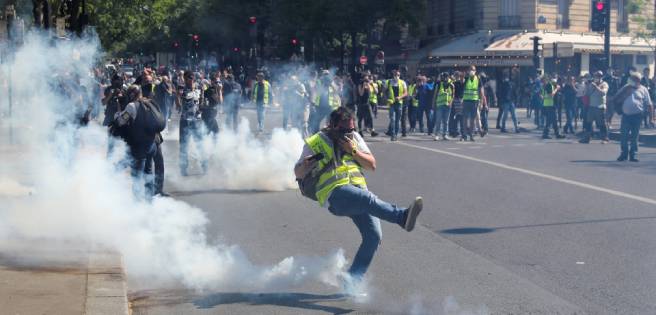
[114,85,157,198]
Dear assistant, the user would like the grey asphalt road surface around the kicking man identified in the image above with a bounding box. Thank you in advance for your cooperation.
[128,110,656,314]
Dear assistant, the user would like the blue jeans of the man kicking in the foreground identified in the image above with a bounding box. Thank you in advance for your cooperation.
[328,185,407,277]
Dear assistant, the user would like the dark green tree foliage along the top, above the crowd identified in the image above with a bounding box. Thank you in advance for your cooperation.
[80,0,426,58]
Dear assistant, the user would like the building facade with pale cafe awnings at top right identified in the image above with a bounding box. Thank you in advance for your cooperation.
[415,0,656,75]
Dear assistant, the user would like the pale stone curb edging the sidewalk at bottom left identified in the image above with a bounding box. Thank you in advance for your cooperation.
[84,252,129,315]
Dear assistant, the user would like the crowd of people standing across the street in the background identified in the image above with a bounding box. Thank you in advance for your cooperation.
[59,61,656,200]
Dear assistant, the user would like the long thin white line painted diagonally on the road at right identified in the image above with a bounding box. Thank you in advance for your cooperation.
[397,142,656,205]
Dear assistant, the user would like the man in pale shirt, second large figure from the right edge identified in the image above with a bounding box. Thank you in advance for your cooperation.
[579,71,608,143]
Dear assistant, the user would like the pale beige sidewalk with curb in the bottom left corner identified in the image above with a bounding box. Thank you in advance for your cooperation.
[0,248,128,315]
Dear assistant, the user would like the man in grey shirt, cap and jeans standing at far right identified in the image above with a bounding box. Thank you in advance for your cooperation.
[614,71,652,162]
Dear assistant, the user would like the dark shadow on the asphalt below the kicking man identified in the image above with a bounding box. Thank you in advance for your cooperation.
[194,293,353,314]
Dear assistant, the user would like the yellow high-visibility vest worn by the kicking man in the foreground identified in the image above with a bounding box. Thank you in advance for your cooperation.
[305,132,367,206]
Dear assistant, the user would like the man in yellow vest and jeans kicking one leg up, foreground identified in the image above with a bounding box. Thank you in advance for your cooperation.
[294,107,423,285]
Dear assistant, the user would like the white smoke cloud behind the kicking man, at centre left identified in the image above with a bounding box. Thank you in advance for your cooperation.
[166,118,303,191]
